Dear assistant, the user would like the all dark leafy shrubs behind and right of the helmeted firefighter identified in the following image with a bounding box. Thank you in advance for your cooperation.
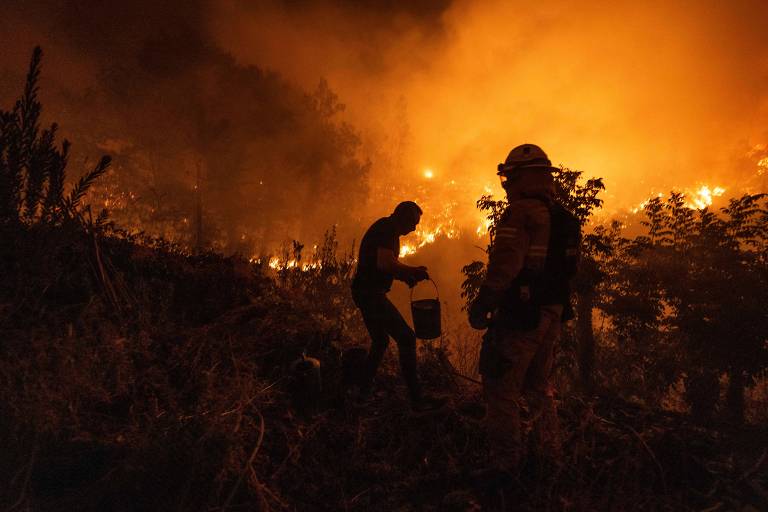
[462,164,768,422]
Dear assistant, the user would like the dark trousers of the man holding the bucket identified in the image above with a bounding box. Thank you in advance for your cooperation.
[352,291,421,402]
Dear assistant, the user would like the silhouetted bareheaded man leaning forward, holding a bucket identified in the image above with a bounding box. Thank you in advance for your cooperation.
[352,201,435,410]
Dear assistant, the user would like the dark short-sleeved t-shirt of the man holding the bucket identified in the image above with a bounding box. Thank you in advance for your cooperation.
[352,217,400,293]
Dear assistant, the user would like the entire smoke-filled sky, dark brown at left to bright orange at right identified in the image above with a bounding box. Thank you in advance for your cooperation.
[0,0,768,253]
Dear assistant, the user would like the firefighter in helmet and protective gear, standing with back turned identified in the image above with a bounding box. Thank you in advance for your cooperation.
[469,144,581,472]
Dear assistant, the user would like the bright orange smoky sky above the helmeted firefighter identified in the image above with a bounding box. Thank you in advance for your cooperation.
[210,0,768,210]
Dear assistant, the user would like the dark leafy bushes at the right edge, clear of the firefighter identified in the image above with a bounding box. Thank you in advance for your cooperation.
[600,192,768,422]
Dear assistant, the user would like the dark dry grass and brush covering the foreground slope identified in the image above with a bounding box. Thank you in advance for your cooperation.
[0,228,768,511]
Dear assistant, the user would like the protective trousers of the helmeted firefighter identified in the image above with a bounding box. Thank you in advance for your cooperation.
[483,305,563,471]
